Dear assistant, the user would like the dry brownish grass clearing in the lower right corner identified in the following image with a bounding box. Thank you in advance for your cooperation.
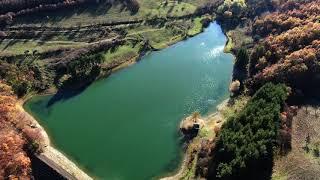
[273,107,320,180]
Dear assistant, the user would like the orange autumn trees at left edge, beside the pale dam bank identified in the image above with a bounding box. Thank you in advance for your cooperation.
[0,82,31,179]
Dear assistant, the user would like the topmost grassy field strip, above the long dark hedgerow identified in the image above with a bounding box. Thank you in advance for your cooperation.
[14,0,209,27]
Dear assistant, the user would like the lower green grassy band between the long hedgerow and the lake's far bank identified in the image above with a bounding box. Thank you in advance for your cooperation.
[0,17,202,54]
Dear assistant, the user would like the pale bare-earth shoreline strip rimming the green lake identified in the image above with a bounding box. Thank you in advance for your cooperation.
[20,19,225,180]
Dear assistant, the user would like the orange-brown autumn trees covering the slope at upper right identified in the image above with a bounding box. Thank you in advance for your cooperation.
[248,0,320,93]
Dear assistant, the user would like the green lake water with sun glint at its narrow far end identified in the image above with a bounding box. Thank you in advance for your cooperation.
[25,23,232,180]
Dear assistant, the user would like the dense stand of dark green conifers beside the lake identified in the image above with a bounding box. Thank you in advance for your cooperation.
[208,83,287,179]
